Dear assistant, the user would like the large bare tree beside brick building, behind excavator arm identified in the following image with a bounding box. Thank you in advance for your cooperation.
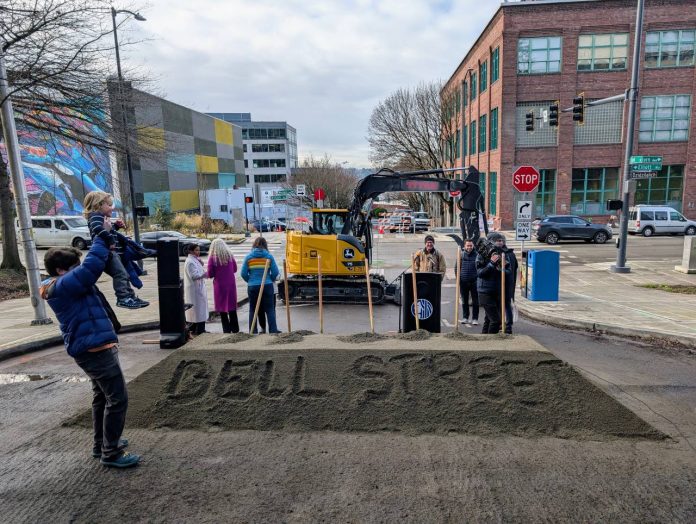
[368,82,460,224]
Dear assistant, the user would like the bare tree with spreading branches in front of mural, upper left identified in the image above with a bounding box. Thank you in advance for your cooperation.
[0,0,150,270]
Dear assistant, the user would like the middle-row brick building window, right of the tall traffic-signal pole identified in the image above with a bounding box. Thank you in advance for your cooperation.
[639,95,691,142]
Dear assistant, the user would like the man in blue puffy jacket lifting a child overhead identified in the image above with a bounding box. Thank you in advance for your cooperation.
[41,235,140,468]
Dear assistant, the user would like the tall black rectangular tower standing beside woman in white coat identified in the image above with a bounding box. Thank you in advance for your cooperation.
[157,237,187,349]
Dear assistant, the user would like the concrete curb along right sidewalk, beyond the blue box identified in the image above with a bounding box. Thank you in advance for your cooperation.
[517,302,696,350]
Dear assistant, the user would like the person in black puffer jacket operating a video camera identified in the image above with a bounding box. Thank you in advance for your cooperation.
[476,233,510,333]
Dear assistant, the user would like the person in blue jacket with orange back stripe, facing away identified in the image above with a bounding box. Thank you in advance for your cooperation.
[241,237,280,333]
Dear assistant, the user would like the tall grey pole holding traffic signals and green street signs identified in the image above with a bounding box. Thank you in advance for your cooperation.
[610,0,645,273]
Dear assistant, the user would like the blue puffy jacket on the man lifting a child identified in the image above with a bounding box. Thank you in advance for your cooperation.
[41,237,118,357]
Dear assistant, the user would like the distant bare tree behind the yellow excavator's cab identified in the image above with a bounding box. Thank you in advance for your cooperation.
[288,155,358,209]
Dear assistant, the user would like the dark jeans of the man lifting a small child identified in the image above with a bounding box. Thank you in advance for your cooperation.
[75,347,128,460]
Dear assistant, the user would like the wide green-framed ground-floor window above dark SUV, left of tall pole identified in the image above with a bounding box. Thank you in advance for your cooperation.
[570,167,620,215]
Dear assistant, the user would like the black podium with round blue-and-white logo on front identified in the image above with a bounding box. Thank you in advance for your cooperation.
[400,273,442,333]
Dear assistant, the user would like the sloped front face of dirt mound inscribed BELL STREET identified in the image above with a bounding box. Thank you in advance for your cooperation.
[76,349,664,440]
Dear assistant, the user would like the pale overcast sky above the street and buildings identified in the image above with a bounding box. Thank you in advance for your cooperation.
[122,0,500,167]
